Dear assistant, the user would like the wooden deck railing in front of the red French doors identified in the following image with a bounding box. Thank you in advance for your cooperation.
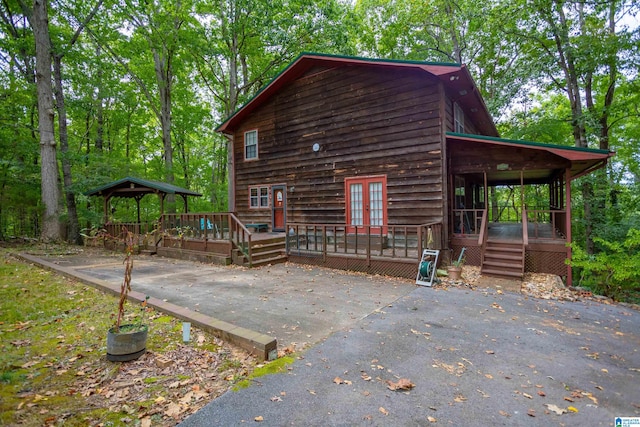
[286,223,443,259]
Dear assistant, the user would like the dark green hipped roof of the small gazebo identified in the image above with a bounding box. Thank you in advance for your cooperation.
[84,176,202,198]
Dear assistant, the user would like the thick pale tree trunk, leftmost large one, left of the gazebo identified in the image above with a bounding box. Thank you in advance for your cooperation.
[31,0,62,241]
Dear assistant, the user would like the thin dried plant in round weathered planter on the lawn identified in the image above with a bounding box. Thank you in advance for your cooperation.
[107,226,149,362]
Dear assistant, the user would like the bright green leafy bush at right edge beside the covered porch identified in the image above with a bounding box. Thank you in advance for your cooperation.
[571,228,640,302]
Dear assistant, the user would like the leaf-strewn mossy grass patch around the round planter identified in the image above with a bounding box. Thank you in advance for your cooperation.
[0,249,255,426]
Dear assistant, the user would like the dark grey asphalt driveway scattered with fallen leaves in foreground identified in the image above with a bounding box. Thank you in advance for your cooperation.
[181,284,640,427]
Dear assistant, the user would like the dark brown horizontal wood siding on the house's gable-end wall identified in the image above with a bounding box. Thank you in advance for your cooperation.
[234,66,443,225]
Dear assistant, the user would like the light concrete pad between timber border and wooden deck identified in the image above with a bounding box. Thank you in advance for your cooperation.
[18,248,415,356]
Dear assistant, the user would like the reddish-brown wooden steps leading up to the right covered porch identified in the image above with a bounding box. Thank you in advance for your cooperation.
[481,238,525,280]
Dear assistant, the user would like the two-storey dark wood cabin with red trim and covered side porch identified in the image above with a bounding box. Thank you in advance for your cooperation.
[210,54,613,288]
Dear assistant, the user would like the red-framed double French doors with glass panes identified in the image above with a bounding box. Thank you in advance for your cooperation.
[345,176,387,233]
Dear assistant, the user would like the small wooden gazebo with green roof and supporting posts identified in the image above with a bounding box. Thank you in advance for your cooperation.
[85,177,202,223]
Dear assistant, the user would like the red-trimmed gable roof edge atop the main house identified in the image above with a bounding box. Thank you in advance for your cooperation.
[216,53,498,136]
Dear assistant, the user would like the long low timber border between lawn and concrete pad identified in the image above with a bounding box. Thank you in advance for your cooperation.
[15,253,278,360]
